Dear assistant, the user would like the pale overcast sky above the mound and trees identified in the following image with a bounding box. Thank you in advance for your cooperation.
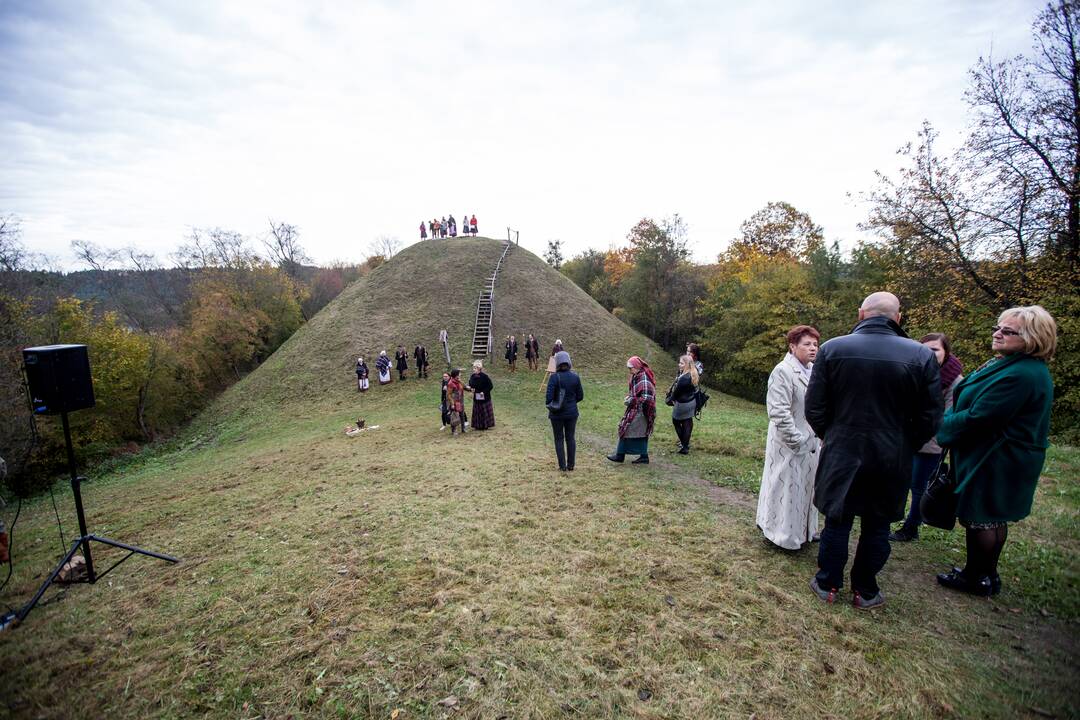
[0,0,1043,268]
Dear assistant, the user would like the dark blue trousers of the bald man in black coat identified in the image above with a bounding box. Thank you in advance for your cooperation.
[818,515,892,598]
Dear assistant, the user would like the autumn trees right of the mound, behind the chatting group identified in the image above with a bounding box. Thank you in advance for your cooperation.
[545,0,1080,440]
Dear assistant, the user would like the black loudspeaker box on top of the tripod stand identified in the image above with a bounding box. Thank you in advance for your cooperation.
[23,345,94,415]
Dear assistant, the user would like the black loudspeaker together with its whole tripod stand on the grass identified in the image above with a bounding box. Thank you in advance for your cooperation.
[0,344,179,629]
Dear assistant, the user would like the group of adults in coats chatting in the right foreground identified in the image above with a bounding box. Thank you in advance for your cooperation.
[757,293,1057,610]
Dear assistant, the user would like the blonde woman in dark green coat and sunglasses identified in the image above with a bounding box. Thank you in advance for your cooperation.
[937,305,1057,596]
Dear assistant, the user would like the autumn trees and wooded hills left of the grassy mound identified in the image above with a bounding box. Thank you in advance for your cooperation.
[0,222,386,493]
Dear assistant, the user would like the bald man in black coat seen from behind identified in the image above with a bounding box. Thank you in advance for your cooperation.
[806,293,943,610]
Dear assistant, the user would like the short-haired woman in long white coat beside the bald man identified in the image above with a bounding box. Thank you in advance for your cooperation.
[757,325,821,551]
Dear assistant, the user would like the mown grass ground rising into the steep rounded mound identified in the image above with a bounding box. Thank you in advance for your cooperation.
[0,241,1080,720]
